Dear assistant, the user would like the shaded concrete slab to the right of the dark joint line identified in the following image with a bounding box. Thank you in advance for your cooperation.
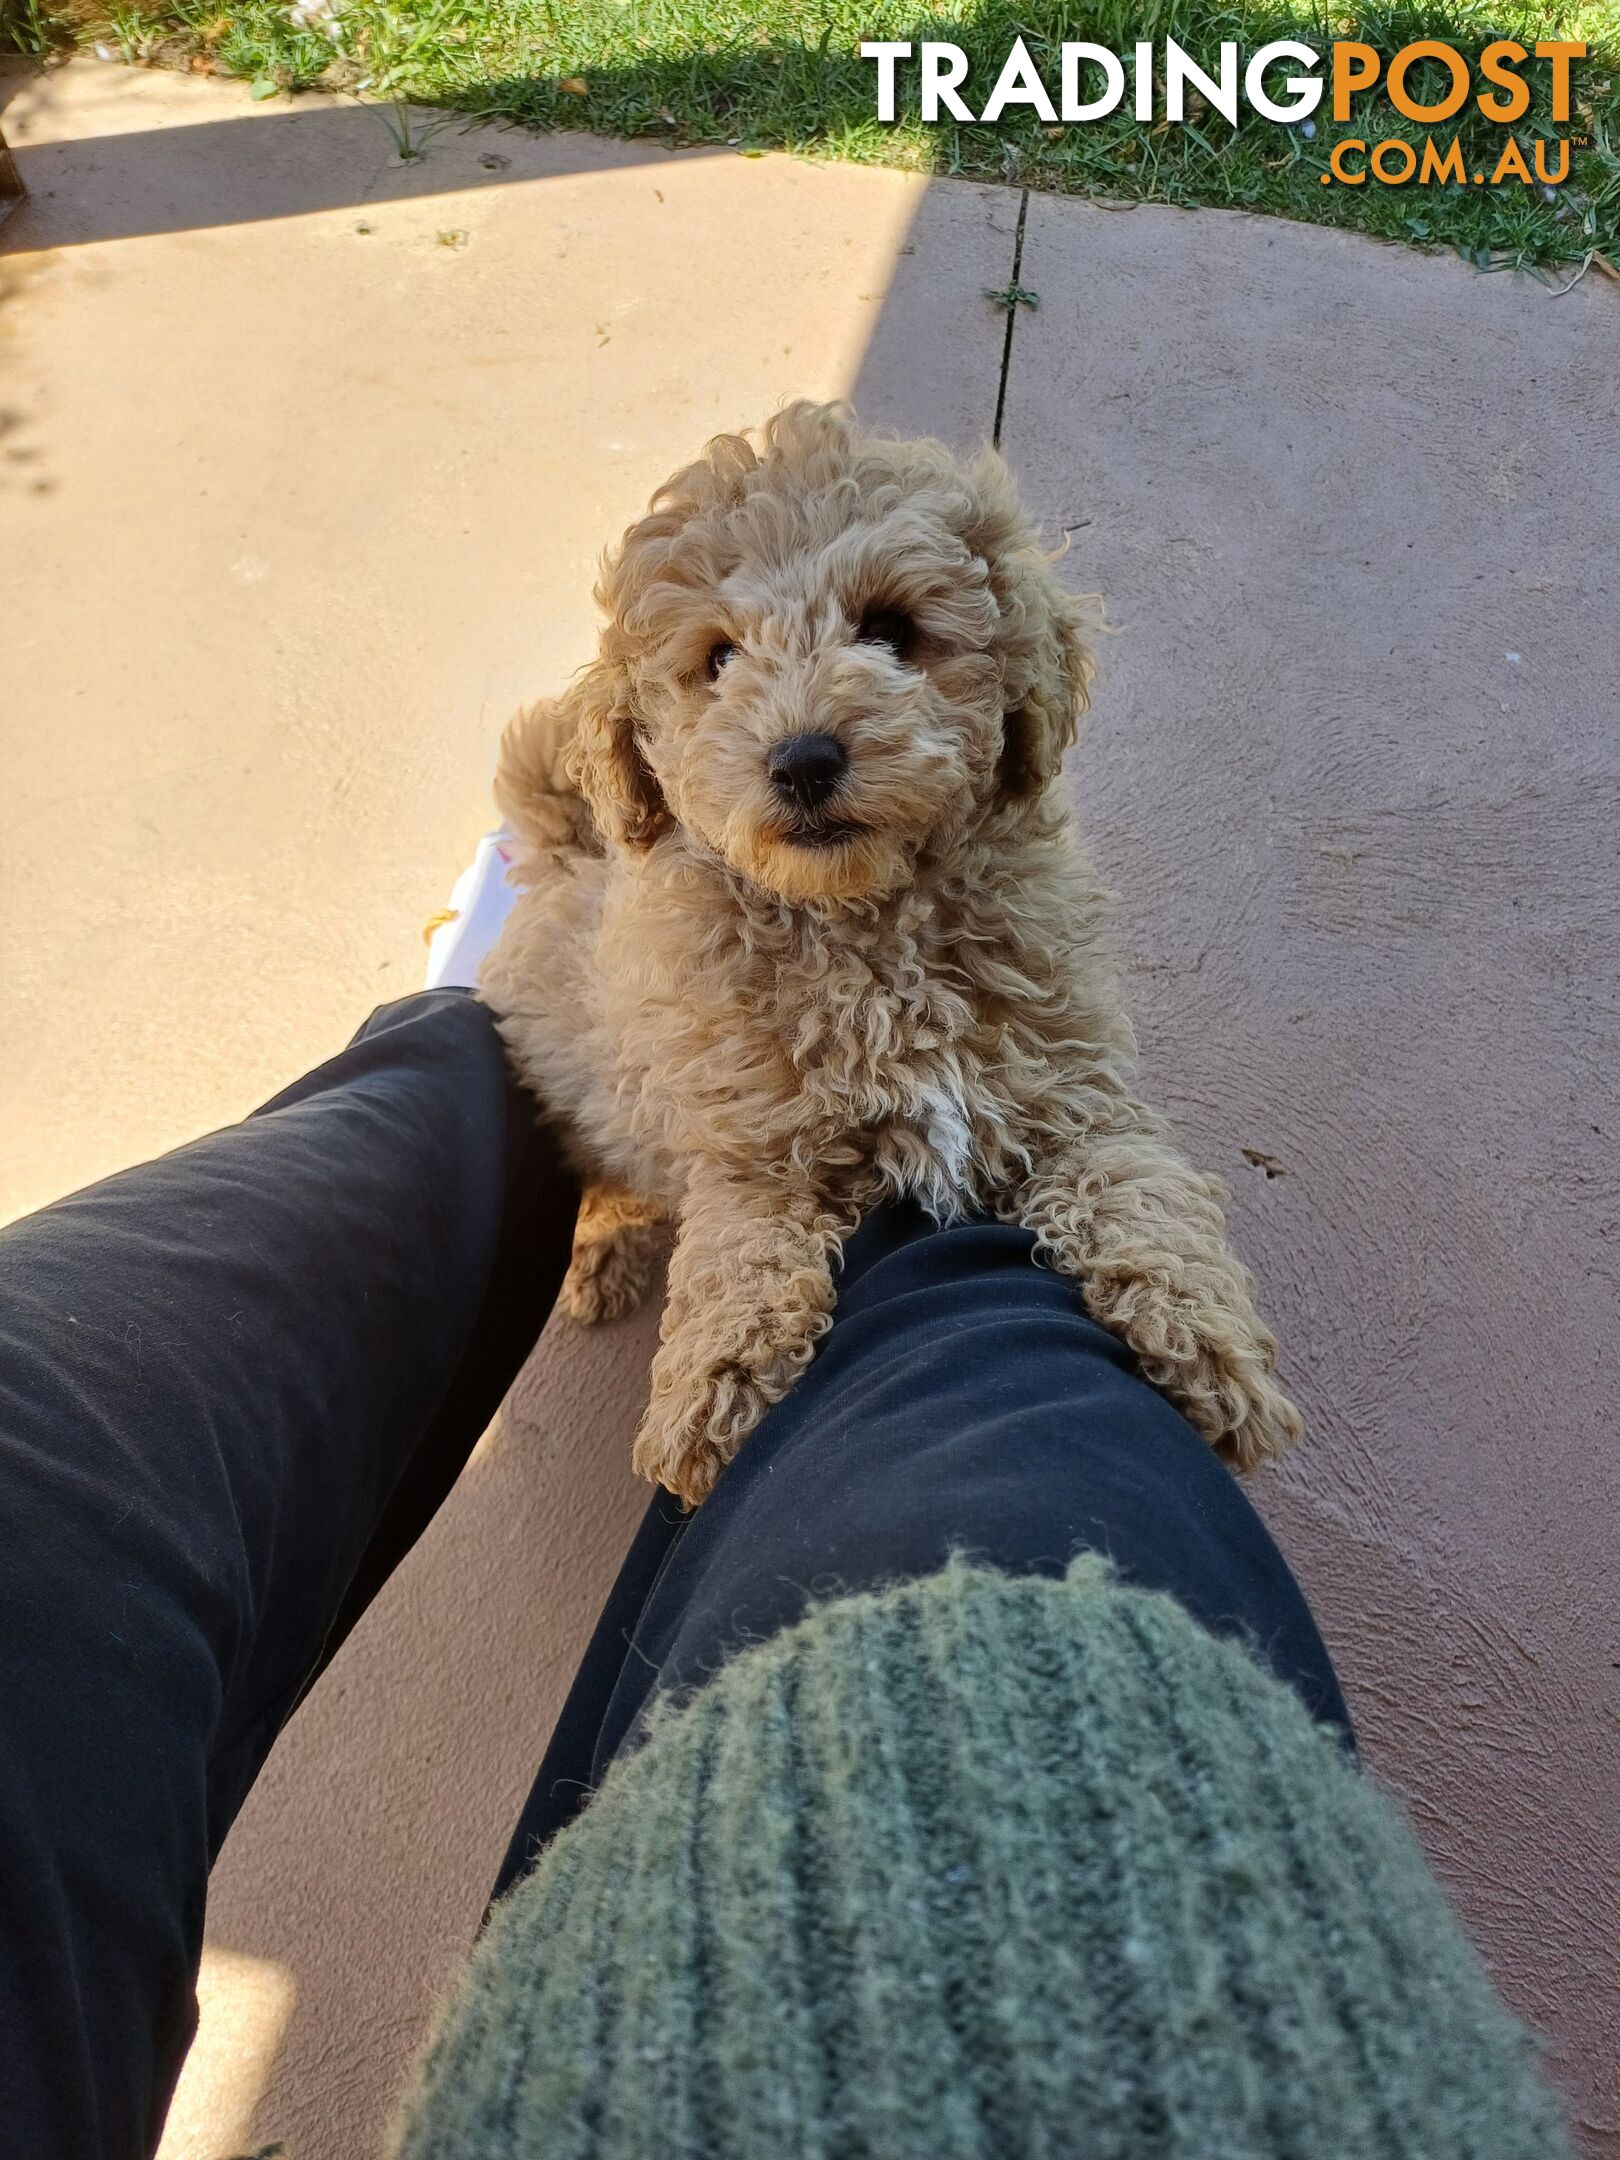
[1004,199,1620,2154]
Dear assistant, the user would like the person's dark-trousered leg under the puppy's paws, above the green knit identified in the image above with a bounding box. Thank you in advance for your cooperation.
[495,1210,1350,1896]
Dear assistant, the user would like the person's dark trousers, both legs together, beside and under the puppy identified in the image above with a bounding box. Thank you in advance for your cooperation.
[0,991,1348,2160]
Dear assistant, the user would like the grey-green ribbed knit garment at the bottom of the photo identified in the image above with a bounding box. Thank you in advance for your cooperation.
[395,1560,1566,2160]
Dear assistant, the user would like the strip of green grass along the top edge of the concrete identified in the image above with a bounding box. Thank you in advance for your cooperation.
[0,0,1620,283]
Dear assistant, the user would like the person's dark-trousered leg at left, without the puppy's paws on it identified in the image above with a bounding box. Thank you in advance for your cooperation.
[0,991,575,2160]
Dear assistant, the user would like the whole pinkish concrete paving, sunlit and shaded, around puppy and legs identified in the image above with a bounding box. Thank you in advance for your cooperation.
[0,65,1620,2160]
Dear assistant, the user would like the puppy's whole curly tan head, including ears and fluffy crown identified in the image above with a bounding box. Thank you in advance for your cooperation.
[565,406,1086,903]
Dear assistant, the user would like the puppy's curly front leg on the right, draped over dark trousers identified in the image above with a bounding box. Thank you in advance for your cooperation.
[1004,1104,1300,1471]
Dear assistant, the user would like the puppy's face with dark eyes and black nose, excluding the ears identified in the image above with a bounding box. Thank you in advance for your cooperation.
[626,490,1002,901]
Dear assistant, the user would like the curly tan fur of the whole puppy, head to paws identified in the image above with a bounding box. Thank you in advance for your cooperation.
[482,404,1298,1503]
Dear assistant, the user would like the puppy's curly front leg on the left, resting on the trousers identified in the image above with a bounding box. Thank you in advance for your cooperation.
[635,1173,853,1506]
